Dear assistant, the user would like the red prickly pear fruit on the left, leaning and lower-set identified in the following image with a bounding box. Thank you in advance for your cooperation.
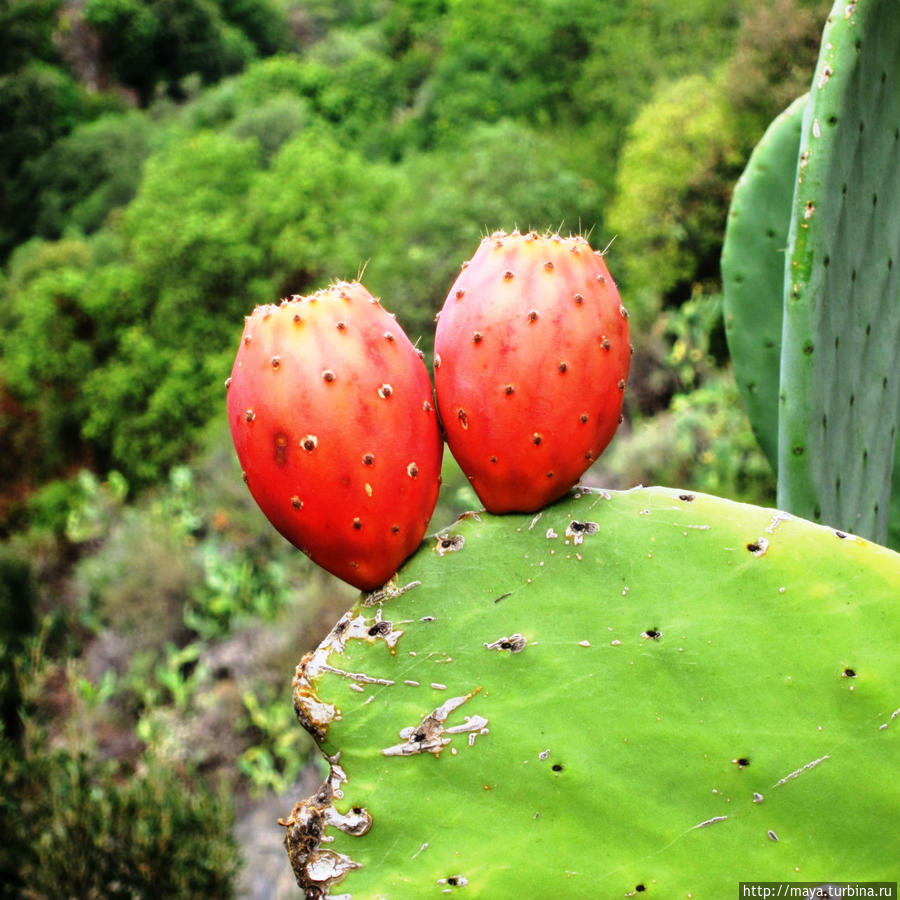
[227,282,443,590]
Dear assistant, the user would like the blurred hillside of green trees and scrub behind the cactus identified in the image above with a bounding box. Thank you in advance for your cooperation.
[0,0,830,897]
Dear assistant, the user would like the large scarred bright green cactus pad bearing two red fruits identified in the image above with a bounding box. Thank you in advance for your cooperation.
[282,488,900,900]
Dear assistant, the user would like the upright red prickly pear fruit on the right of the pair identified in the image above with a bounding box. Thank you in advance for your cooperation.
[434,231,631,513]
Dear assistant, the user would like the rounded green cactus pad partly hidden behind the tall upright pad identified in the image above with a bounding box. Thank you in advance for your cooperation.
[722,95,806,469]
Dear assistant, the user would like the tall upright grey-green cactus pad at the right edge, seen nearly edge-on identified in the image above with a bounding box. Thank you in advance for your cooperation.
[778,0,900,541]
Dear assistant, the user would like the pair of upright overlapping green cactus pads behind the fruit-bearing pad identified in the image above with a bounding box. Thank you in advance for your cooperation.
[722,0,900,546]
